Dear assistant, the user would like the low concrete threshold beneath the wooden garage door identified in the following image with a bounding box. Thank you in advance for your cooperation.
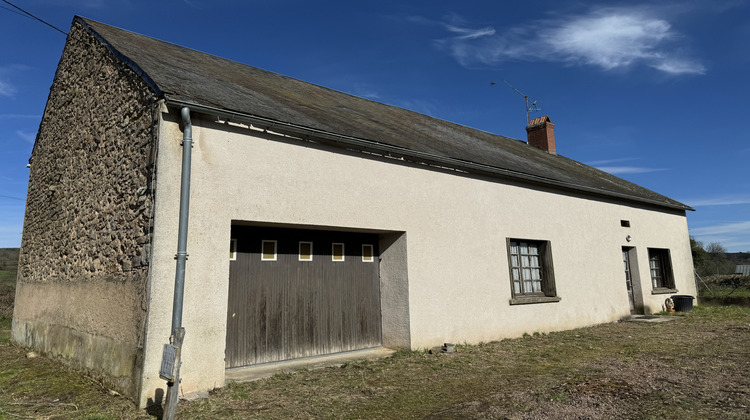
[224,347,396,383]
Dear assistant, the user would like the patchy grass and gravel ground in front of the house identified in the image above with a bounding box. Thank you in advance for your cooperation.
[0,306,750,419]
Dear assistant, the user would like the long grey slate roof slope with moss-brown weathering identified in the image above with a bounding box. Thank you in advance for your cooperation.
[74,16,692,210]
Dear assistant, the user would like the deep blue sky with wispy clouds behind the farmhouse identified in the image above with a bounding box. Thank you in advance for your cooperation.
[0,0,750,252]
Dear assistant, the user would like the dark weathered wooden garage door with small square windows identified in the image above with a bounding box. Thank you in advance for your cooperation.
[226,226,381,368]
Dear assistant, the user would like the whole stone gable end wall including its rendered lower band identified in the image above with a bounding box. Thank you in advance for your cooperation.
[13,24,158,397]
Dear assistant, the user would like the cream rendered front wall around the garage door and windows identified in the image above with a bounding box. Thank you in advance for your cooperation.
[141,106,695,405]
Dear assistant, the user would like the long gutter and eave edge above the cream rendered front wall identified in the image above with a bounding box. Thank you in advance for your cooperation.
[165,96,695,211]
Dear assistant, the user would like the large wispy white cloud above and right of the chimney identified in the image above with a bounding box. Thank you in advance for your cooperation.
[437,7,706,75]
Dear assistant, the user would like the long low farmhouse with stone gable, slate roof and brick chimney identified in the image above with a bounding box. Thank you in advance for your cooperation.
[13,17,695,406]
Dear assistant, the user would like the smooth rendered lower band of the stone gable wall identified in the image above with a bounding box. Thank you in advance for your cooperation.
[12,281,144,398]
